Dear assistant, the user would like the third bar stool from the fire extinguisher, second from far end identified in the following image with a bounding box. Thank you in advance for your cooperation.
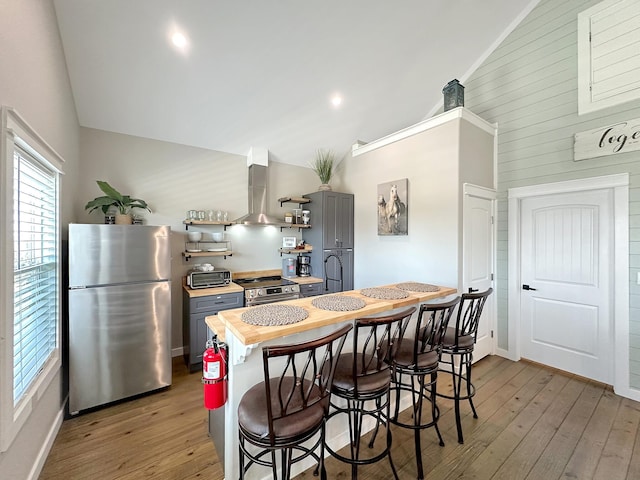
[390,297,460,479]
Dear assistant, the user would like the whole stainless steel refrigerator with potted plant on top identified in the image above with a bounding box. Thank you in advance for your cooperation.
[68,224,171,415]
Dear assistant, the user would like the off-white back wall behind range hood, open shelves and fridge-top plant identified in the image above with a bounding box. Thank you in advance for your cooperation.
[75,128,319,353]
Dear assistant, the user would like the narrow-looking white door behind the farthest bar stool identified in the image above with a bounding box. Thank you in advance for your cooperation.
[462,188,495,362]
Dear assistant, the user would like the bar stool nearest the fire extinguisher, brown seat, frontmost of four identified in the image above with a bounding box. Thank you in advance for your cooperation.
[238,325,353,480]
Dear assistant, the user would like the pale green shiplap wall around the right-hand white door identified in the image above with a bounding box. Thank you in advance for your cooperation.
[464,0,640,388]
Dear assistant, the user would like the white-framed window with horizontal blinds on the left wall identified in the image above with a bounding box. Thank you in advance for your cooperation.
[0,105,64,452]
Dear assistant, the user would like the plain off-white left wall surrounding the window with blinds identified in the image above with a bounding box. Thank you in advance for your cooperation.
[0,0,79,480]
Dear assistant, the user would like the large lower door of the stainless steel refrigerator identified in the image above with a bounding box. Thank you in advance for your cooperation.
[69,282,171,414]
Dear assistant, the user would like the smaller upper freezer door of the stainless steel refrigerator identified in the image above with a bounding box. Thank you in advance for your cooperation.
[69,223,171,287]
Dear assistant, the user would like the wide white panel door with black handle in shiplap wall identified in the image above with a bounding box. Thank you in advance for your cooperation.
[520,189,613,384]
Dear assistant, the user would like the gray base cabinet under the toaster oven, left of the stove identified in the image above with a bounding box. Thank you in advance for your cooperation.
[182,291,244,373]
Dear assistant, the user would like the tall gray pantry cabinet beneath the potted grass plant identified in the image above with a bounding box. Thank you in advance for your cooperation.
[302,191,354,294]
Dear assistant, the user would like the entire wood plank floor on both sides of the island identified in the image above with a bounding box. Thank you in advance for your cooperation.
[40,357,640,480]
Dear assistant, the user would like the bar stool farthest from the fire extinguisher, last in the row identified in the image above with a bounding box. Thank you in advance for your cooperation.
[438,288,493,443]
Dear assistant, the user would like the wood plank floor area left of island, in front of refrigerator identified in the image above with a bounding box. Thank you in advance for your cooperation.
[40,357,224,480]
